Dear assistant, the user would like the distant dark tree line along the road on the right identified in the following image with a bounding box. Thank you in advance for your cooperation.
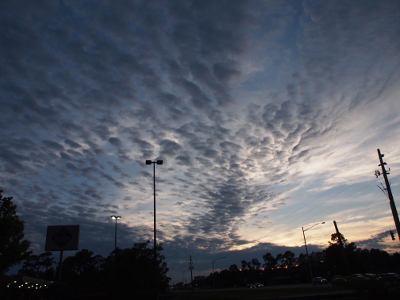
[198,233,400,288]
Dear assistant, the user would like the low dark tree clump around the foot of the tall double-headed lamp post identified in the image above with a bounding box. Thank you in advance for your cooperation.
[13,241,170,299]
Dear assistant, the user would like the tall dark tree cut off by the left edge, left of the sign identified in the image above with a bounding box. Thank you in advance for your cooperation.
[0,191,31,276]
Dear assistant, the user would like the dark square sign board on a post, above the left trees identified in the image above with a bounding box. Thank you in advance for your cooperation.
[44,225,80,251]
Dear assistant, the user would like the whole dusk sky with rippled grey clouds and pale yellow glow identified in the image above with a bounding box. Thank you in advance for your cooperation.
[0,0,400,282]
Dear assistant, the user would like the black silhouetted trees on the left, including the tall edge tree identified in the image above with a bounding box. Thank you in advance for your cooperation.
[0,191,170,299]
